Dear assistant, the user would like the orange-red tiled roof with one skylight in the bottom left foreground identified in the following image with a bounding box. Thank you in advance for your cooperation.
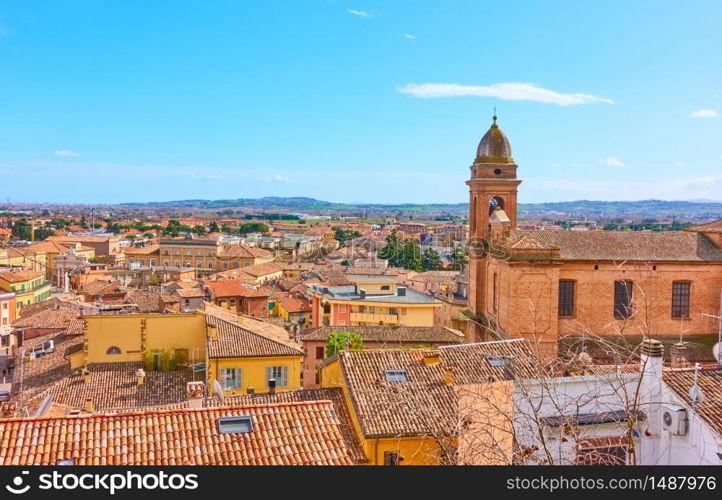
[0,401,353,465]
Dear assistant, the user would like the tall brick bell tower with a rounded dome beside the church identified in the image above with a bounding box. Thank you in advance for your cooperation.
[466,114,521,342]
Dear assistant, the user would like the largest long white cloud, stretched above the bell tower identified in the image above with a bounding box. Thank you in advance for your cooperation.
[397,82,614,106]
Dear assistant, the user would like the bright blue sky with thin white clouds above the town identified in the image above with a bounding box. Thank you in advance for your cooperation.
[0,0,722,203]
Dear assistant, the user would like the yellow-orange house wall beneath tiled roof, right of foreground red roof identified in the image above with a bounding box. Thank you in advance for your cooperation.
[320,359,439,465]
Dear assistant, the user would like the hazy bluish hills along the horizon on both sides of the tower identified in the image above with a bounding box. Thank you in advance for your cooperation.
[121,196,722,219]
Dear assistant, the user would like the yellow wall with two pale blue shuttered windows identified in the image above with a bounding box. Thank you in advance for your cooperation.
[208,355,302,394]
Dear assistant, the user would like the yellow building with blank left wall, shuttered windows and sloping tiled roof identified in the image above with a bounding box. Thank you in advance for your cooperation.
[82,312,303,395]
